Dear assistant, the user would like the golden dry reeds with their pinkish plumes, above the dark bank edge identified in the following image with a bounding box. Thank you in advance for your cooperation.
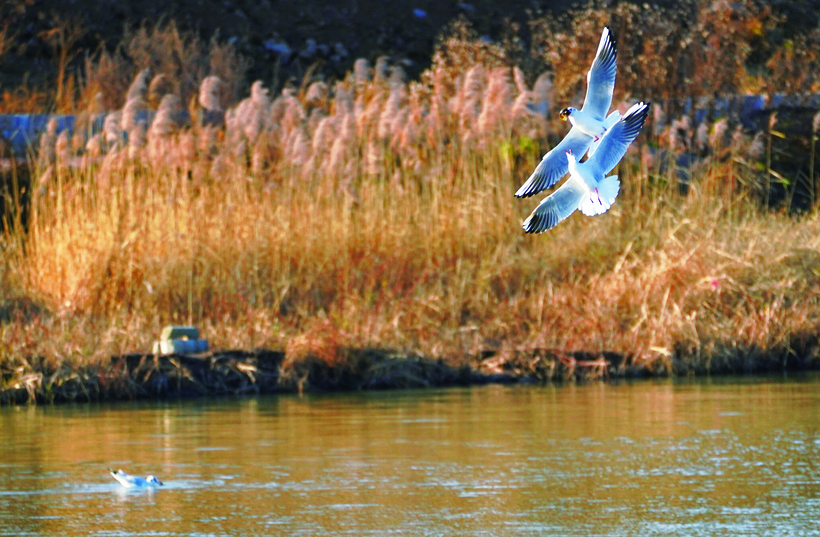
[0,2,820,400]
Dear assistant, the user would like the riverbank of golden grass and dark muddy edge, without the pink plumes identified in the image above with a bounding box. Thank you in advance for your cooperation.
[6,147,820,403]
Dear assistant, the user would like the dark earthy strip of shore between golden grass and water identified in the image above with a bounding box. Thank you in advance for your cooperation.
[0,342,820,406]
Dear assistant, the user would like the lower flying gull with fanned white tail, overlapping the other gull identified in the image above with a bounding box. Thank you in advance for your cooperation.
[522,102,649,233]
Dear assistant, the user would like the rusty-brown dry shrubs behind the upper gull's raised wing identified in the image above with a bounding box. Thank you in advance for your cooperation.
[530,0,796,102]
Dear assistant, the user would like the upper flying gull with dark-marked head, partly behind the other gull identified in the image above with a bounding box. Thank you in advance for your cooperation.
[515,26,621,198]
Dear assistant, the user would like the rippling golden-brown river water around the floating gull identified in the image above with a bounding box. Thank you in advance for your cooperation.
[0,375,820,536]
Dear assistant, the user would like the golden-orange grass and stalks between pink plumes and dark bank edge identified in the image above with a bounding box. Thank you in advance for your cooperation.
[6,122,820,376]
